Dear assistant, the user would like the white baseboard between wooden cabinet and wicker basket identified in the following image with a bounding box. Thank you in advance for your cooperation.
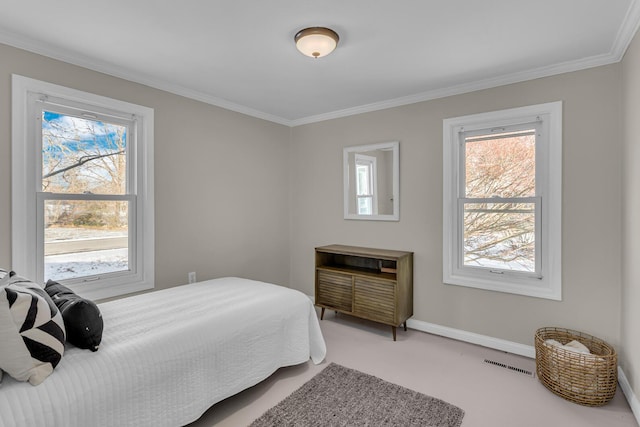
[407,319,536,359]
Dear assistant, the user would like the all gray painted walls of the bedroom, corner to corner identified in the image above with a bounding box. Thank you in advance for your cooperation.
[0,37,640,402]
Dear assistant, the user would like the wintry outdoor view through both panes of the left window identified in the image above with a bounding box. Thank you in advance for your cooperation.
[42,111,129,280]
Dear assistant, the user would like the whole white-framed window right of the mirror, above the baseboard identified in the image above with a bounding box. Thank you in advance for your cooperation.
[443,102,562,300]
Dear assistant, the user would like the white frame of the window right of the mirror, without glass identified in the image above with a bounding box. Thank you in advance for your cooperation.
[443,101,562,301]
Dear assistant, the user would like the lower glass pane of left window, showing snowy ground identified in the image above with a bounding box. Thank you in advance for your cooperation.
[44,200,129,281]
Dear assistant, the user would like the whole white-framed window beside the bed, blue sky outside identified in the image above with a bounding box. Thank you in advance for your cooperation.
[12,75,154,299]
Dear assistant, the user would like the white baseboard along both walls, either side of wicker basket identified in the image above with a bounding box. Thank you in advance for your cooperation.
[407,319,640,425]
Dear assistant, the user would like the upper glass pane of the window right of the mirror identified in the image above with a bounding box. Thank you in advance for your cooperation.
[465,130,536,198]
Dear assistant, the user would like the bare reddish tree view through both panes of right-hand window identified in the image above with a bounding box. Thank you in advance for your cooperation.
[464,130,536,272]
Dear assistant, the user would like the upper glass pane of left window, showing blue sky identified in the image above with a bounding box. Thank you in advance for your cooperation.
[42,111,127,194]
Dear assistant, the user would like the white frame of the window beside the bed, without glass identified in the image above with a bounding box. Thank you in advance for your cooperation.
[11,75,155,300]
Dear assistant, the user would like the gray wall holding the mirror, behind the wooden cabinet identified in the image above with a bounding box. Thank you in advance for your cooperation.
[290,64,622,345]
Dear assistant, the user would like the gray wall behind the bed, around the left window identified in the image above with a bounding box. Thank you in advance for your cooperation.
[0,44,290,289]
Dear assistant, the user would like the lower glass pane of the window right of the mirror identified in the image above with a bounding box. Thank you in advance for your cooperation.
[464,203,536,272]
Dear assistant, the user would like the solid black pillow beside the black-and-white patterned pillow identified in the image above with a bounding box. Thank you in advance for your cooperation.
[44,280,104,351]
